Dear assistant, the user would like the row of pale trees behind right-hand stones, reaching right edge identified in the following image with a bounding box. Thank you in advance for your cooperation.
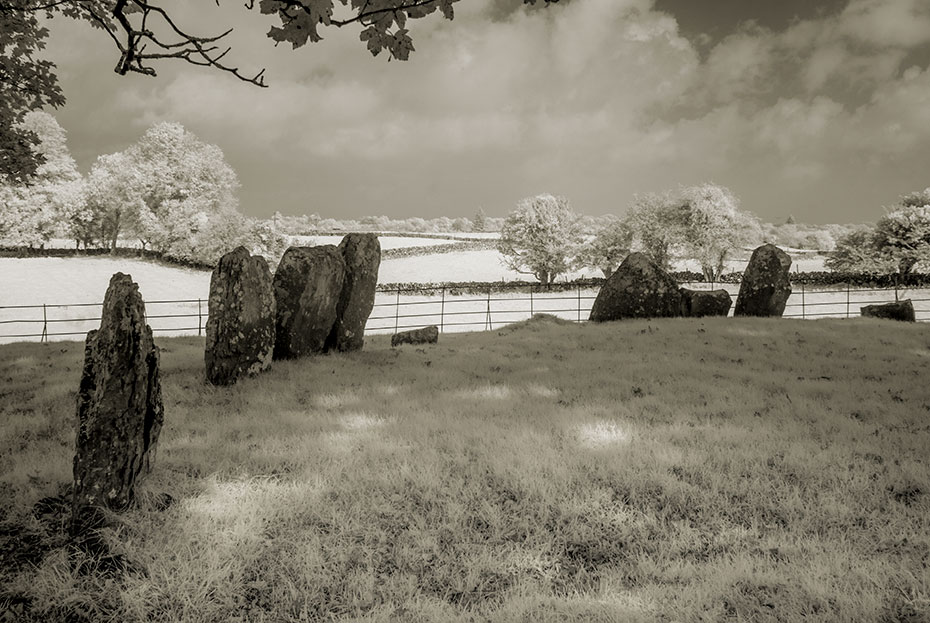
[497,183,930,284]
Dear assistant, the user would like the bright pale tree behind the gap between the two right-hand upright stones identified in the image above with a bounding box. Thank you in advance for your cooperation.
[680,183,762,281]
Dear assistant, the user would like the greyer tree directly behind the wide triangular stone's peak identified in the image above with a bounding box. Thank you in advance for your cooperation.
[625,192,688,269]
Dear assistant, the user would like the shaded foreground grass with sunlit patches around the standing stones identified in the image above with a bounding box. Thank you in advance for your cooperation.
[0,318,930,622]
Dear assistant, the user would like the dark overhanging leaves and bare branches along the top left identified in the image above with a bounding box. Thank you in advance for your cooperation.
[0,0,558,182]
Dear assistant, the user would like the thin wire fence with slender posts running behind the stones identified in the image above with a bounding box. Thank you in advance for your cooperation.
[0,283,930,343]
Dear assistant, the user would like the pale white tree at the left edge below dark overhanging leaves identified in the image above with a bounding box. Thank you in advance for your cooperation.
[0,111,84,246]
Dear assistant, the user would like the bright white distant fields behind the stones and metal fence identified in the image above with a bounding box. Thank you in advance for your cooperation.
[0,249,930,342]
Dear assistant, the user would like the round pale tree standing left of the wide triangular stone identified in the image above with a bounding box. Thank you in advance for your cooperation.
[497,194,582,284]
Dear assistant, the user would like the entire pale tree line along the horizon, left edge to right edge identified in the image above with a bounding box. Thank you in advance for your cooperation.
[0,111,930,284]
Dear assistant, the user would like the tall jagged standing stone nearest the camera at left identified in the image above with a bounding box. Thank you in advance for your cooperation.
[71,273,164,535]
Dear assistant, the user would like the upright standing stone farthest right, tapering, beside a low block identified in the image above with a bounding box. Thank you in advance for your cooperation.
[733,244,791,316]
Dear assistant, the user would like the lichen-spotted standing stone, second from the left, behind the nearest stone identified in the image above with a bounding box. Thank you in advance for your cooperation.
[204,247,275,385]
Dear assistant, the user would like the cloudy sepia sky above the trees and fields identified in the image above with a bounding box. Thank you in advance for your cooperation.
[45,0,930,223]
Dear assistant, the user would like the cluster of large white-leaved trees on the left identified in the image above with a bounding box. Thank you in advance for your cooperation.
[0,111,285,264]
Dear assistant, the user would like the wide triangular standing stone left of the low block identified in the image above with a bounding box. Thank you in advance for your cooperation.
[589,253,681,322]
